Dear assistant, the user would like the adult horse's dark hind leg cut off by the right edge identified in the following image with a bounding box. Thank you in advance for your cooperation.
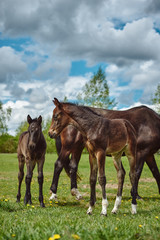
[146,155,160,194]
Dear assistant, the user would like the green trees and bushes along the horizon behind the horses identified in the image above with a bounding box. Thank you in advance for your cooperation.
[0,67,160,153]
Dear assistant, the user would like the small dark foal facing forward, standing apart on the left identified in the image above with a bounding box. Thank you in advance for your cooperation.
[17,115,46,207]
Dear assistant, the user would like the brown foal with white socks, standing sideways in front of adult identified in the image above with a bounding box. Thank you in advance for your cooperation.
[50,98,137,215]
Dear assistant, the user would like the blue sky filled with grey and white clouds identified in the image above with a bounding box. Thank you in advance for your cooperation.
[0,0,160,135]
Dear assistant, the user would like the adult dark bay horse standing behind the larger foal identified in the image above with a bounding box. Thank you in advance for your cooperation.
[49,102,160,199]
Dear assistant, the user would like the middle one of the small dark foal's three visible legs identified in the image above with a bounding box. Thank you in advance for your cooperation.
[24,157,35,204]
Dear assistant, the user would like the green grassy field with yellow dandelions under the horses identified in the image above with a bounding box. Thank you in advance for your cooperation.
[0,154,160,240]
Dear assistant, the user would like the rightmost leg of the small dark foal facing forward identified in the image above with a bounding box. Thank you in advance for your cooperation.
[38,156,45,207]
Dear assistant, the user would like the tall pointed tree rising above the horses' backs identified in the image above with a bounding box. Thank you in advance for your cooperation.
[77,67,117,109]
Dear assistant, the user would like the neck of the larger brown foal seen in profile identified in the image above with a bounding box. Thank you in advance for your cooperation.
[64,105,100,136]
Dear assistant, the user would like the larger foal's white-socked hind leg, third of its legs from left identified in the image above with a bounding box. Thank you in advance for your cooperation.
[112,153,126,214]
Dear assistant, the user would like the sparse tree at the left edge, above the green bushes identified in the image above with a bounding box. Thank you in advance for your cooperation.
[0,101,12,135]
